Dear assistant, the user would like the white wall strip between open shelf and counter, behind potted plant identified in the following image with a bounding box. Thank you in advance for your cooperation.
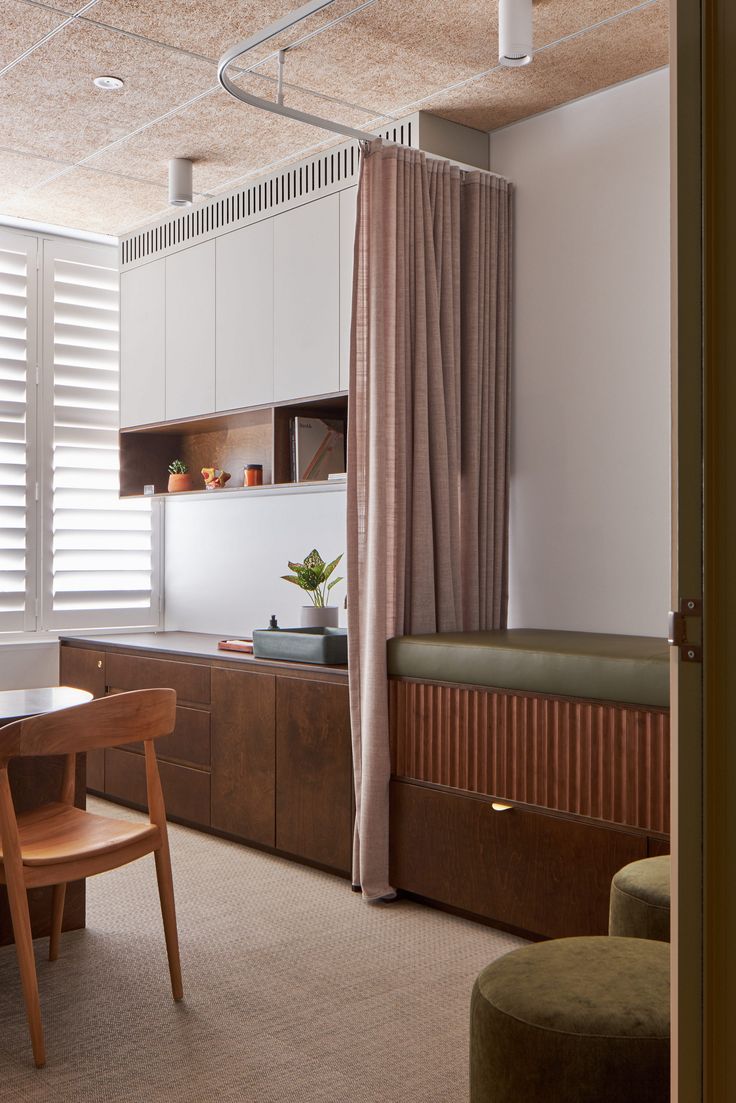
[164,486,345,635]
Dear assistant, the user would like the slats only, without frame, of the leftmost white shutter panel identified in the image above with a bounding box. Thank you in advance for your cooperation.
[0,246,30,630]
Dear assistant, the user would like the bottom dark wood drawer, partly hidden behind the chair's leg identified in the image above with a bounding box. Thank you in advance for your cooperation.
[105,747,210,827]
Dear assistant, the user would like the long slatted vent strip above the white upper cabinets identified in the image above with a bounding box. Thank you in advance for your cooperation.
[120,120,412,268]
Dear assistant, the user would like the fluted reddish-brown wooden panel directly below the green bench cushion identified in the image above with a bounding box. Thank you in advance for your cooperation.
[391,678,670,832]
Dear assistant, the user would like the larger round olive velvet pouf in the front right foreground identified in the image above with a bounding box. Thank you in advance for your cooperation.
[470,936,670,1103]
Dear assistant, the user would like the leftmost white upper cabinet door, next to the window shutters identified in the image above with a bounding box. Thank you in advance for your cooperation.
[120,259,166,428]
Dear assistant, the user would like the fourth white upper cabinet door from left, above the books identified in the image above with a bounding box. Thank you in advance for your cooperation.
[274,194,340,401]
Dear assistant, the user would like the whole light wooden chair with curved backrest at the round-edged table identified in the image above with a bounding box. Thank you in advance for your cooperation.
[0,689,183,1068]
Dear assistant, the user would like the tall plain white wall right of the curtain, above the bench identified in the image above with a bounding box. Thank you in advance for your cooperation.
[490,71,670,635]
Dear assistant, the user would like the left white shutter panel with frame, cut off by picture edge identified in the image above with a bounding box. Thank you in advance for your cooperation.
[0,231,38,631]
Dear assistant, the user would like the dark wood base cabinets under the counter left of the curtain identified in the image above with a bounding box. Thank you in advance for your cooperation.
[61,638,353,875]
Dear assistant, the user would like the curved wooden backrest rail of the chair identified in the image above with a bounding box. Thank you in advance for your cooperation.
[0,689,177,764]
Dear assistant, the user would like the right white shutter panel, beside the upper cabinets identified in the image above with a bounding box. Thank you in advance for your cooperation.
[43,240,158,628]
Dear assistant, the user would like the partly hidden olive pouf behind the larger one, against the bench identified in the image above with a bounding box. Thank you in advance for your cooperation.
[608,855,670,942]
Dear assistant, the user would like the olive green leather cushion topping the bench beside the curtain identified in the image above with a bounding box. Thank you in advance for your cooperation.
[387,628,670,707]
